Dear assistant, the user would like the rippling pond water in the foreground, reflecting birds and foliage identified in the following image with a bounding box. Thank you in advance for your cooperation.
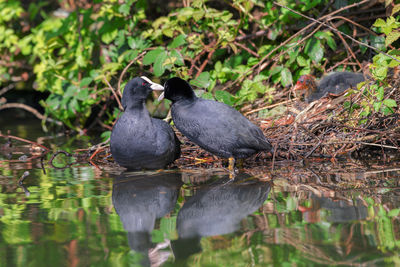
[0,114,400,266]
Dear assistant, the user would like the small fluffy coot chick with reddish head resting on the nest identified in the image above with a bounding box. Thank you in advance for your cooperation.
[294,71,365,103]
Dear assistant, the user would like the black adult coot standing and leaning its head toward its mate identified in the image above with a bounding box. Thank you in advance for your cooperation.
[160,77,272,174]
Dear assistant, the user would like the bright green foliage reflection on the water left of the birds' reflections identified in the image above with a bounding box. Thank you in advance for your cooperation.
[0,167,134,266]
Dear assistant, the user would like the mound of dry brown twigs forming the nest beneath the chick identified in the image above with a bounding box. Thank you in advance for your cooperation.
[253,77,400,160]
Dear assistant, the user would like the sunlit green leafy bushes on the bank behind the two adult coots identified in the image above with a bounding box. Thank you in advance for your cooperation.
[0,0,399,129]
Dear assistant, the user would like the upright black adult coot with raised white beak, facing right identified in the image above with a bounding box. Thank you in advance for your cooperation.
[110,77,180,170]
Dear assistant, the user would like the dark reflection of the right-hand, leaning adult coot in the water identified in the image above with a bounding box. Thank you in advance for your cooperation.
[171,174,270,261]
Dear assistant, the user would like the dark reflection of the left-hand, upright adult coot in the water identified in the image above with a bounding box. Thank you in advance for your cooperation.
[112,173,182,266]
